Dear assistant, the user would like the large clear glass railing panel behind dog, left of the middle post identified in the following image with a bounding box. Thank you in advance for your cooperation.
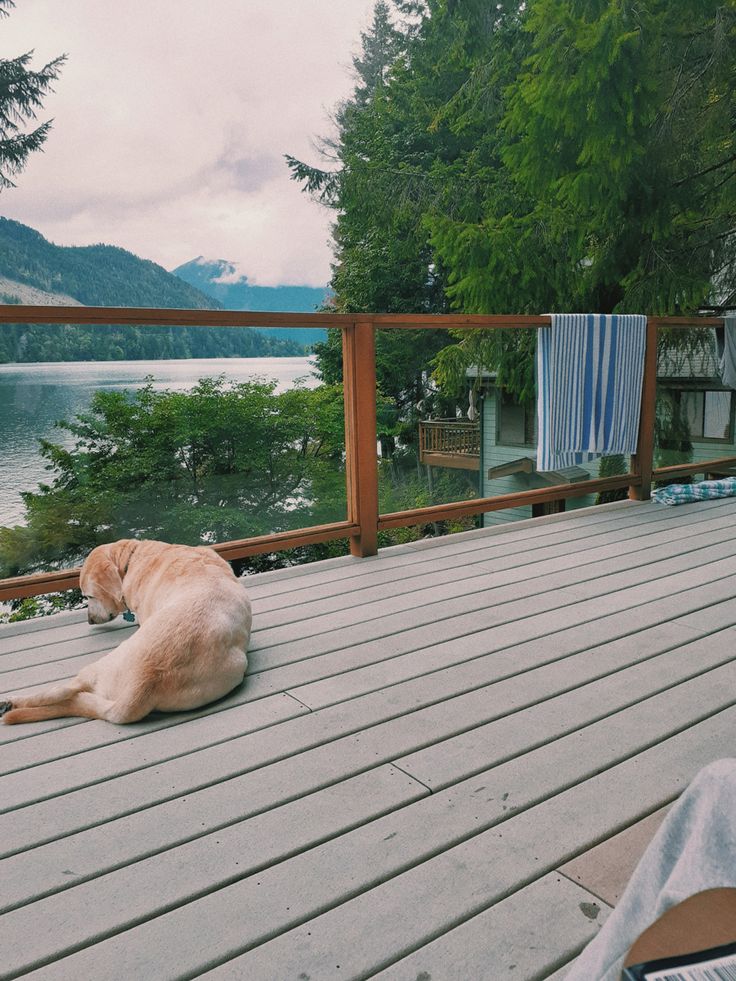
[0,325,346,596]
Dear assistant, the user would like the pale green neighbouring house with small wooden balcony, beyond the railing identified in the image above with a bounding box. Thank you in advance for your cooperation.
[420,328,736,527]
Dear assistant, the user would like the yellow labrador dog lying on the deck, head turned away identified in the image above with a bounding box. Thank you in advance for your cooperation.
[0,539,251,725]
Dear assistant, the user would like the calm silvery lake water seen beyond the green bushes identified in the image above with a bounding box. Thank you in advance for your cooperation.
[0,358,317,527]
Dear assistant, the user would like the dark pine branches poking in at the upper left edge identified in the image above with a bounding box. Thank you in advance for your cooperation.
[0,0,66,189]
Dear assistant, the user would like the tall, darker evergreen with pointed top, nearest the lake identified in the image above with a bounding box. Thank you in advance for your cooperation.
[287,0,454,424]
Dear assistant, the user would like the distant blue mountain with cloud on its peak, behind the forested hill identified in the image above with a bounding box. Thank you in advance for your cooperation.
[172,256,330,344]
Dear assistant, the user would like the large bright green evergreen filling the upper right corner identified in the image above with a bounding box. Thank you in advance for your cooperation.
[430,0,736,314]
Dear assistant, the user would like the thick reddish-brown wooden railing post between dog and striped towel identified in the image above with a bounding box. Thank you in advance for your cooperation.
[343,319,378,558]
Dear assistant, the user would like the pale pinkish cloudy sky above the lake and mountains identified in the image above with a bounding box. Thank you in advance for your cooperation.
[0,0,373,285]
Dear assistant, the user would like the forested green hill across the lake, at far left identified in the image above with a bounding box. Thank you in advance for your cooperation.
[0,218,310,363]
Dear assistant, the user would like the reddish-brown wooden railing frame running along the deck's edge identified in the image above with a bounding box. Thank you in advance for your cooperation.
[0,305,736,600]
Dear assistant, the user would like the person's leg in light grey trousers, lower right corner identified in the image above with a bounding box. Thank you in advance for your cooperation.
[565,759,736,981]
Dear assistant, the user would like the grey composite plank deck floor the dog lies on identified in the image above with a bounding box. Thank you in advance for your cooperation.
[0,500,736,981]
